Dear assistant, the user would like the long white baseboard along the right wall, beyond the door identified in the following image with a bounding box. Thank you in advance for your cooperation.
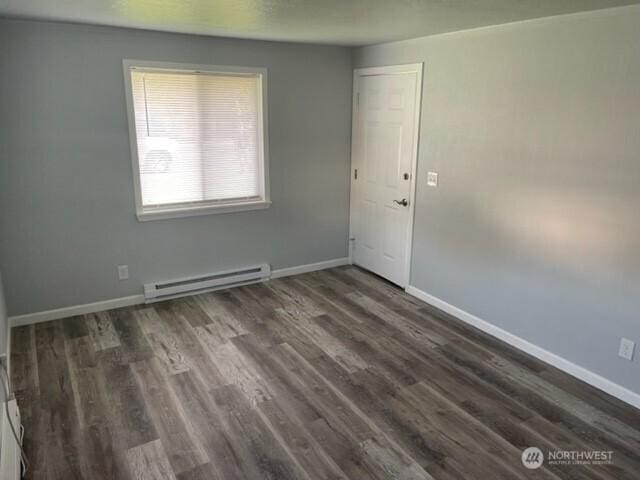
[406,285,640,408]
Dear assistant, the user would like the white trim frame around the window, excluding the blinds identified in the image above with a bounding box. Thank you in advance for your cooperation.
[122,59,271,222]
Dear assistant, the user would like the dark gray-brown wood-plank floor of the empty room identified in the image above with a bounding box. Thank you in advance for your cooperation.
[12,267,640,480]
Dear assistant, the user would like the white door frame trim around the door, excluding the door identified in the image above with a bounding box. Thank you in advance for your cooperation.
[349,62,424,288]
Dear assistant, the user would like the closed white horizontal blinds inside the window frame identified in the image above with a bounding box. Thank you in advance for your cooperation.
[131,71,260,206]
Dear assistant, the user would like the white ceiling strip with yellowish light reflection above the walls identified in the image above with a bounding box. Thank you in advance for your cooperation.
[0,0,640,45]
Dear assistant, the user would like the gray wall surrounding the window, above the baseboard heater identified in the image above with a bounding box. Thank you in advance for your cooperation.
[0,20,352,315]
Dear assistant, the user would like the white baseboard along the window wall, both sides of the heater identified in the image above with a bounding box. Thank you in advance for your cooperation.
[9,257,349,328]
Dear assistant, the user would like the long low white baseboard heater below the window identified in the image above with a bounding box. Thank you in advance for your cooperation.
[144,263,271,303]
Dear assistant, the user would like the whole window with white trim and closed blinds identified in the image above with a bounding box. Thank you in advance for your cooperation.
[124,60,270,220]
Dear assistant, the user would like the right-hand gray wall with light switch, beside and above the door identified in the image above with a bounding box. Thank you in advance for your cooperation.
[354,6,640,392]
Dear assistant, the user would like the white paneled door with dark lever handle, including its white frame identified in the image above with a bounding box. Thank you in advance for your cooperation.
[351,64,422,287]
